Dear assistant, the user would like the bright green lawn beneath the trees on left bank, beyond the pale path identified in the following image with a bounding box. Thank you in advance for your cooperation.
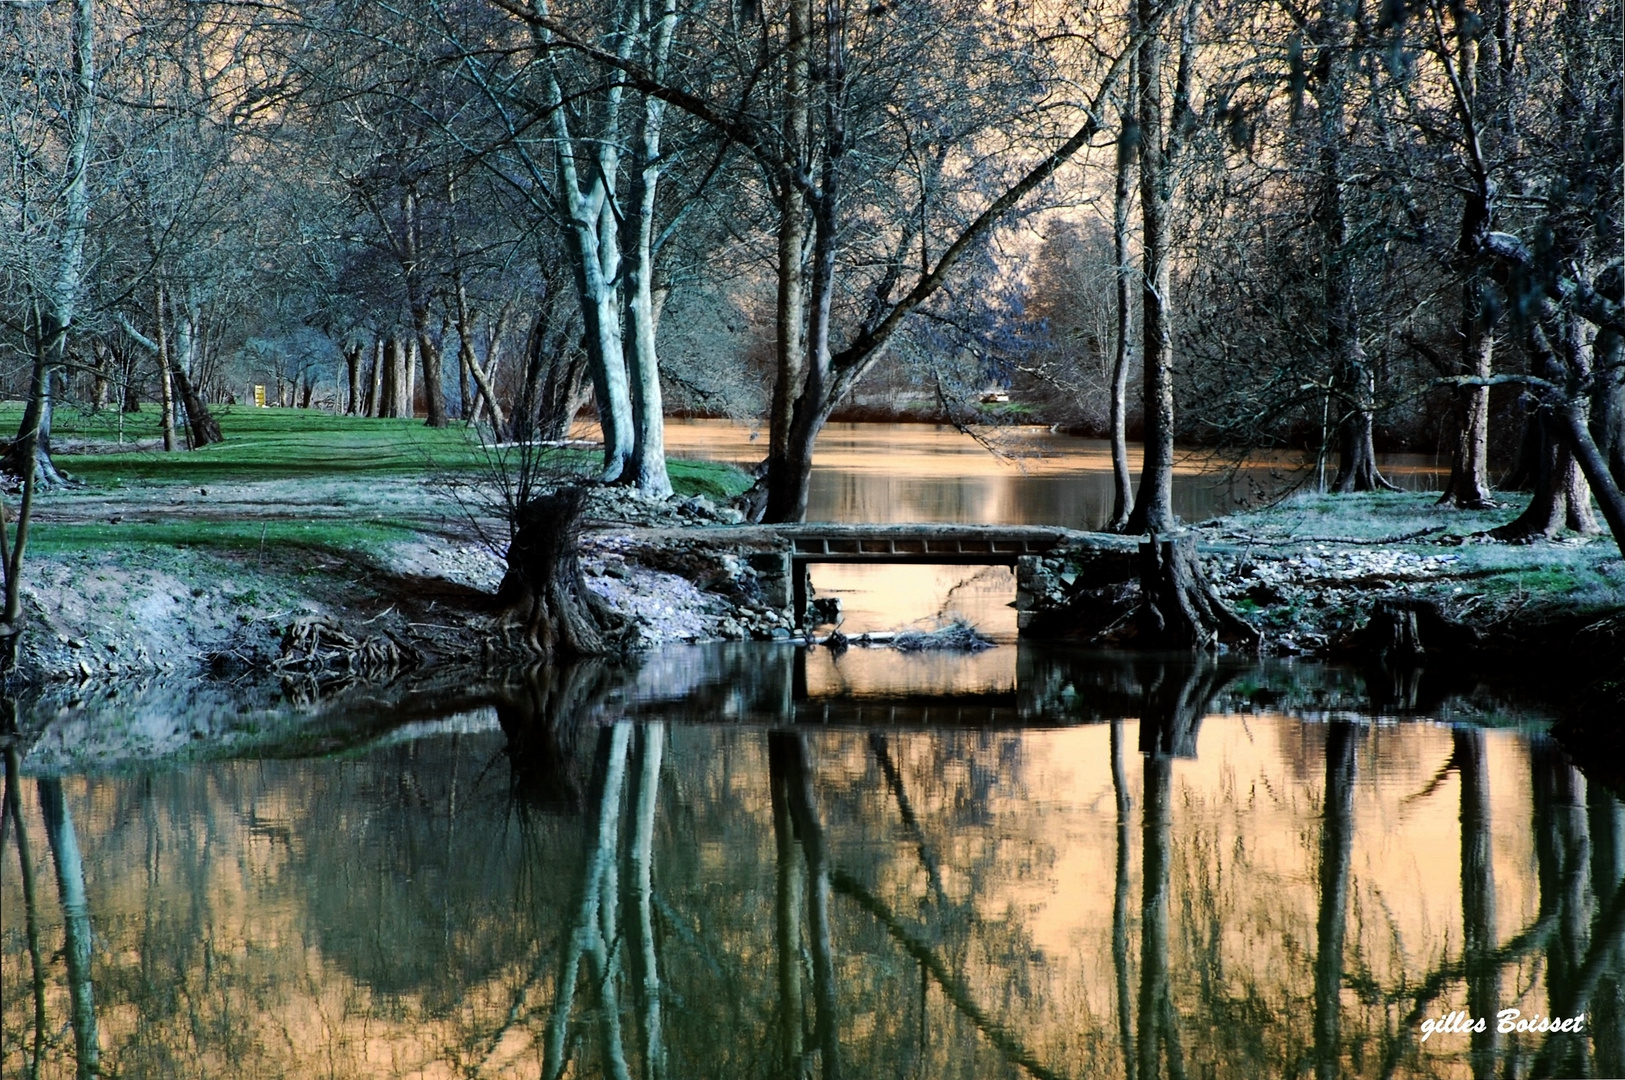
[28,403,749,499]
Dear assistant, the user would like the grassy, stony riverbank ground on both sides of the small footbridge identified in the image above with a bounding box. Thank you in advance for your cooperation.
[12,409,1625,714]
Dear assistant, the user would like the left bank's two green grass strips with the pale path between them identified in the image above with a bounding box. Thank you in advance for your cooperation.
[17,403,749,555]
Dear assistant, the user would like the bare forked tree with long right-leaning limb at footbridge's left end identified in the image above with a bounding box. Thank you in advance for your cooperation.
[520,0,1162,521]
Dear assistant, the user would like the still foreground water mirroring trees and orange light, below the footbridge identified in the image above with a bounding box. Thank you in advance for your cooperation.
[0,648,1625,1080]
